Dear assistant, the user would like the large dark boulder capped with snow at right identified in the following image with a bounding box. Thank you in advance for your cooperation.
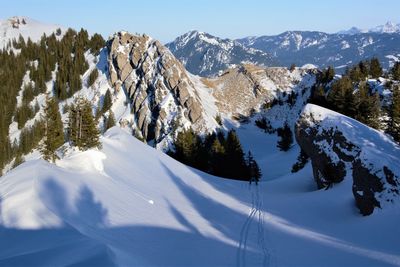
[296,104,400,215]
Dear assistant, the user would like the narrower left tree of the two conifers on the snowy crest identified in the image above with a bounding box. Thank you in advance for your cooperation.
[42,96,64,162]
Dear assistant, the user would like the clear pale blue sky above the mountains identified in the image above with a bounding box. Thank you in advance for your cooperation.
[0,0,400,43]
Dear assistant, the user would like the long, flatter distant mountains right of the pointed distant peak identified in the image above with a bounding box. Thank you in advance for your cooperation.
[238,31,400,71]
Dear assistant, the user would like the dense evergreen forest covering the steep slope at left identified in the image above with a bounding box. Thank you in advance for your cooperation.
[0,29,105,174]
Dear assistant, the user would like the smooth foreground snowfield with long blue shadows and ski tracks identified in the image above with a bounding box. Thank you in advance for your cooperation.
[0,127,400,266]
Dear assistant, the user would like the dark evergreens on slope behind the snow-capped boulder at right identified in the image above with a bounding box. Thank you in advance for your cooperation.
[310,58,400,138]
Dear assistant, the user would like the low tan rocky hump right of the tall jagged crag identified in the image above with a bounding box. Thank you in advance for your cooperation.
[203,64,314,117]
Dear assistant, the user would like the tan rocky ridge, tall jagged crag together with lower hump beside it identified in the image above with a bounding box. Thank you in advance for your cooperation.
[108,32,315,147]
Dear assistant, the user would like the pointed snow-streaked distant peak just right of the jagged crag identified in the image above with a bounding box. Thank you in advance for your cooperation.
[166,31,274,76]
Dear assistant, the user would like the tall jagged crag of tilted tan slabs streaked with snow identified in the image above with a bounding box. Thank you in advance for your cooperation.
[108,32,203,143]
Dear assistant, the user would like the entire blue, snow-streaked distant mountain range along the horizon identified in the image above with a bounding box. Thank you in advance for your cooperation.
[166,22,400,76]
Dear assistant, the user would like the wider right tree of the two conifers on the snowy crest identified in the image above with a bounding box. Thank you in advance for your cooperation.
[68,98,101,150]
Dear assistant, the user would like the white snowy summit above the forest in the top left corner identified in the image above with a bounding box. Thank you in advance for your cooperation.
[0,16,64,48]
